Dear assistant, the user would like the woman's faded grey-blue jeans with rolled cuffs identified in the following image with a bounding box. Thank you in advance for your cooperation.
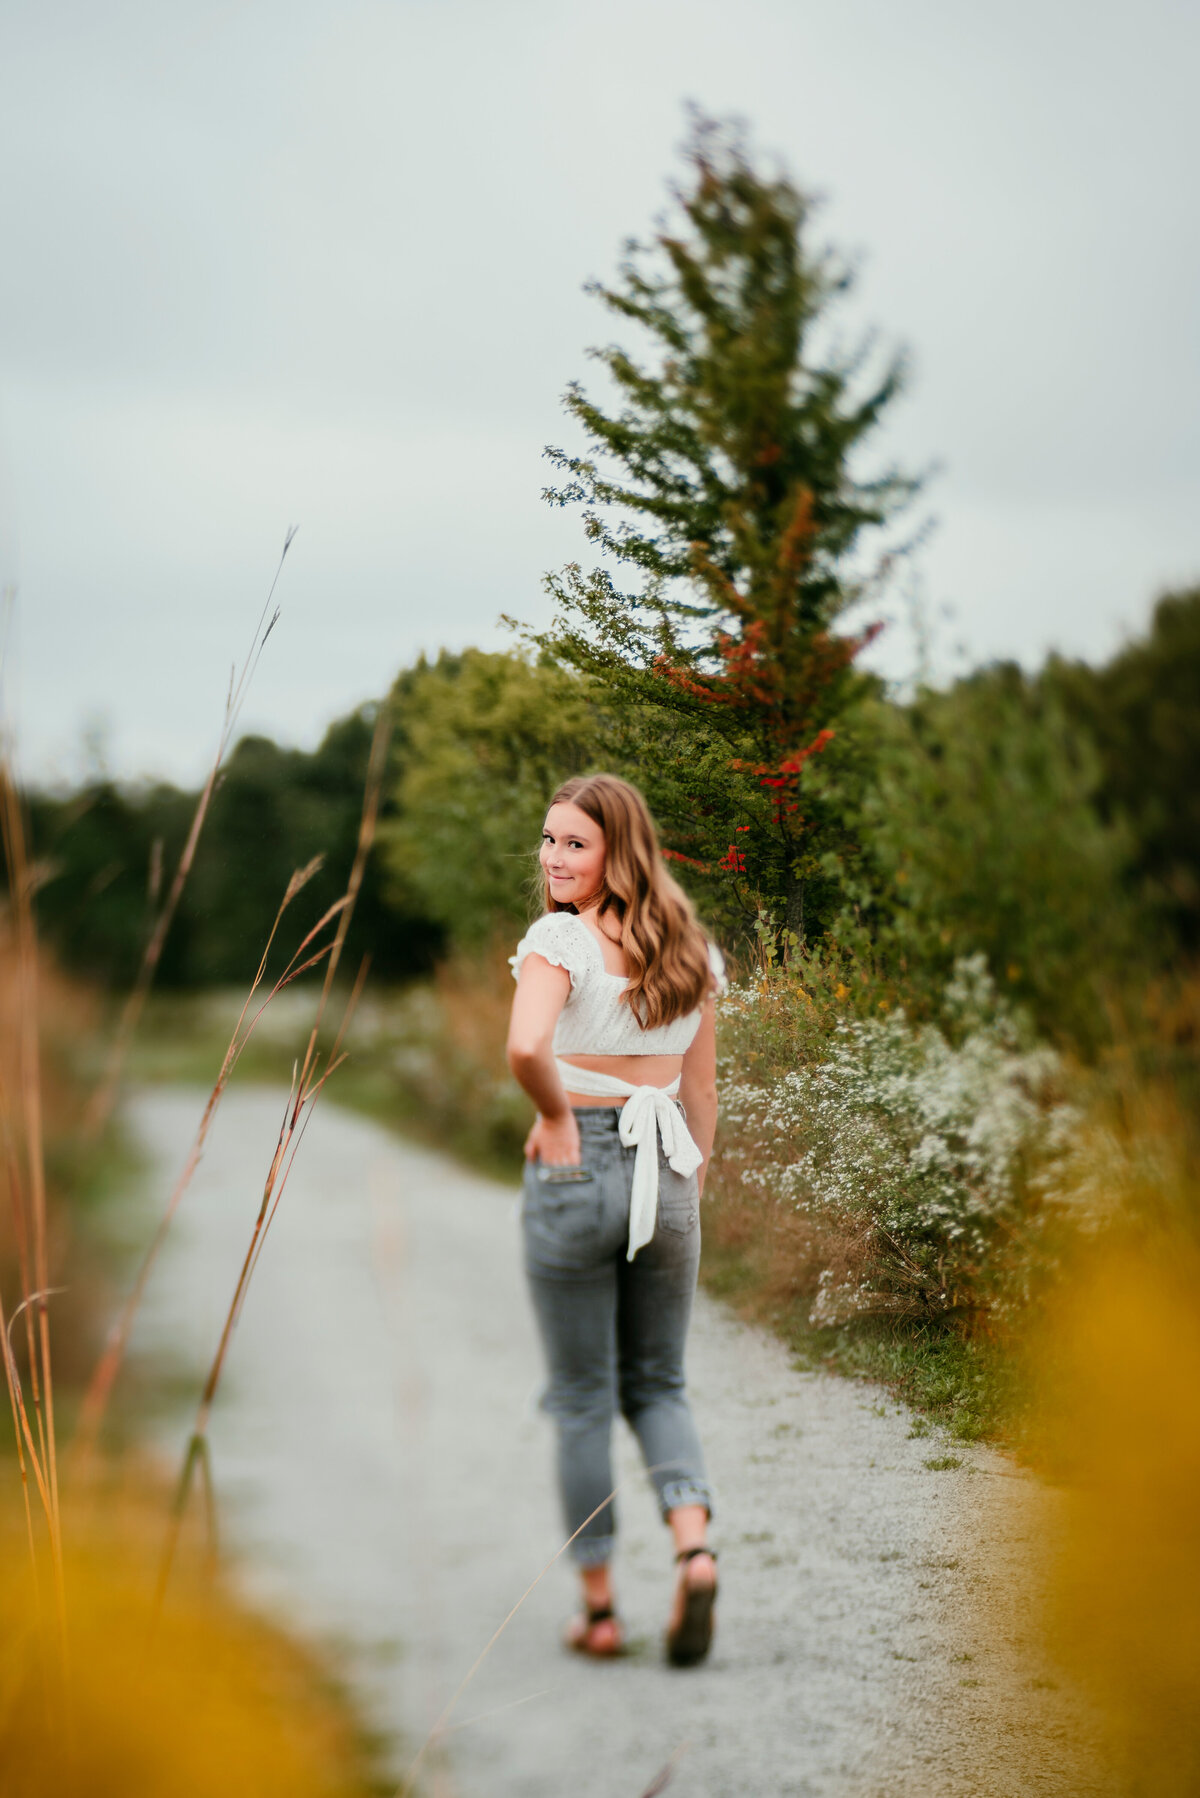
[522,1106,712,1566]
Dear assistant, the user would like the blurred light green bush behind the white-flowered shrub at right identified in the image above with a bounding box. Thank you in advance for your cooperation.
[849,665,1141,1050]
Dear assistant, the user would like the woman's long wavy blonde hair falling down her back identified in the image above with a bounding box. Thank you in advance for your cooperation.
[543,775,712,1030]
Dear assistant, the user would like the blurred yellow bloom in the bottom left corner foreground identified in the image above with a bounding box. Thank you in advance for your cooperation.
[0,1519,367,1798]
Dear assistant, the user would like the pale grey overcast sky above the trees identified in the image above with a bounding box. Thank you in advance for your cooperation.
[0,0,1200,780]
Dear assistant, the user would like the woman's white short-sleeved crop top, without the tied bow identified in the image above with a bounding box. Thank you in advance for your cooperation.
[509,912,725,1055]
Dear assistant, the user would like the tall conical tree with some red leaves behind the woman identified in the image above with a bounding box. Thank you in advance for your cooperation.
[536,117,916,937]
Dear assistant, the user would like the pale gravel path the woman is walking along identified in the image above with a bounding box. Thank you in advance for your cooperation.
[128,1088,1106,1798]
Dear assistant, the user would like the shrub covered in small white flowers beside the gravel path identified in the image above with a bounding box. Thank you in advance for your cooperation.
[721,955,1076,1323]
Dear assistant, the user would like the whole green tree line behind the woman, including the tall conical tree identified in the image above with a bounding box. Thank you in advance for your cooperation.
[11,119,1200,1046]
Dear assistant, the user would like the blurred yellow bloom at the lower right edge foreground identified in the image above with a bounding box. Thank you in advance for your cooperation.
[1036,1241,1200,1798]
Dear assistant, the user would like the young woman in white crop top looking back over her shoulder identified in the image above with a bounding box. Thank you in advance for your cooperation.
[507,775,723,1667]
